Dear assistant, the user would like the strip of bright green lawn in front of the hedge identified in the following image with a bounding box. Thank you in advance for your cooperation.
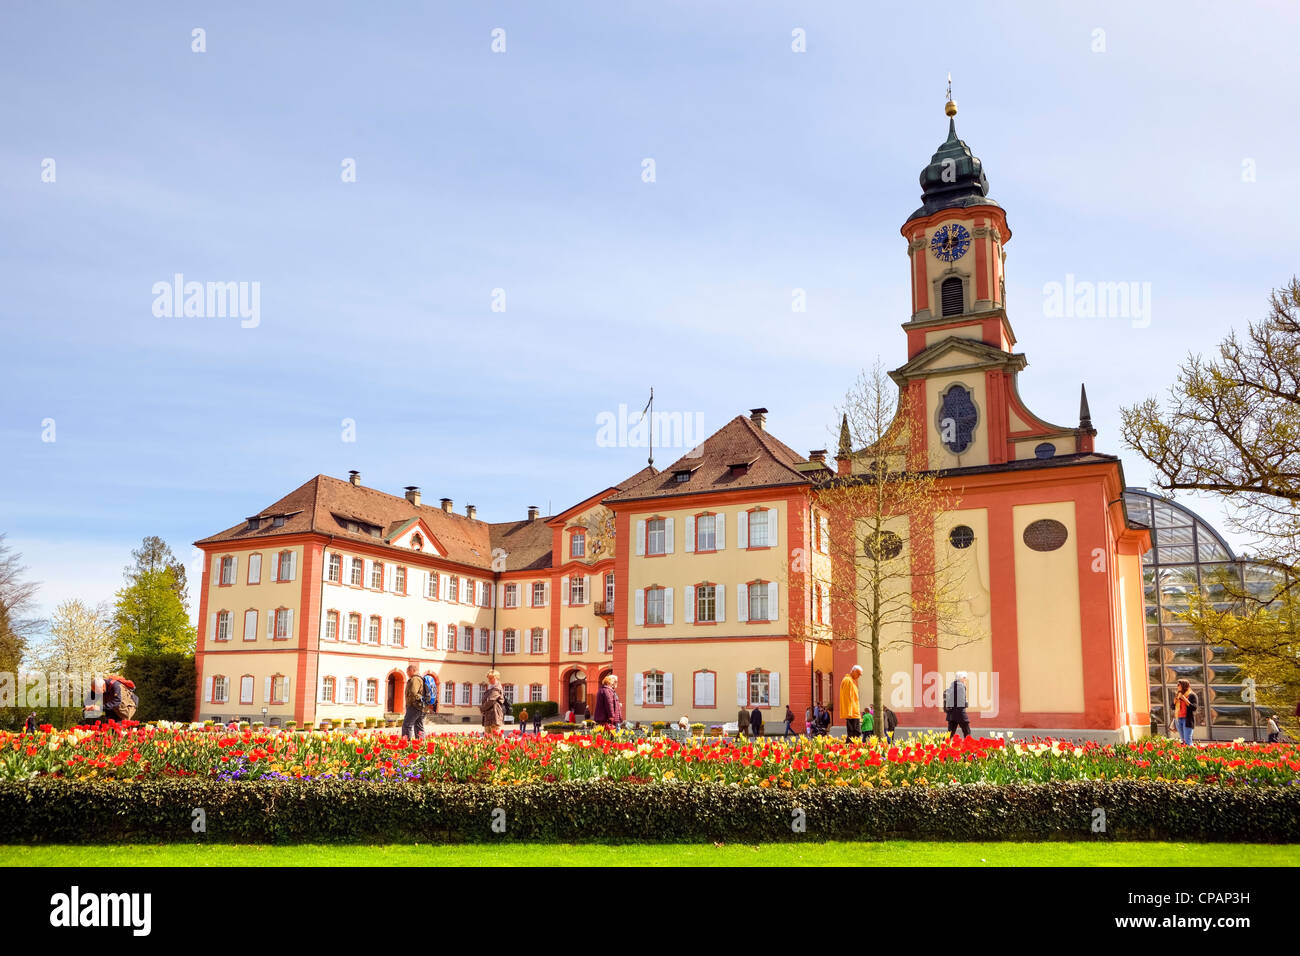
[0,842,1300,866]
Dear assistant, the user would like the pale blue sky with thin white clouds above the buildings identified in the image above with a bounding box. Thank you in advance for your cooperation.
[0,0,1300,629]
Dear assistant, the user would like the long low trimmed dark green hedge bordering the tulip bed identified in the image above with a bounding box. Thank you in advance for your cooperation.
[0,778,1300,844]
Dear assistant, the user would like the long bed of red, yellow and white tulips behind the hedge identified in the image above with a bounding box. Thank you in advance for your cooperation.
[0,726,1300,790]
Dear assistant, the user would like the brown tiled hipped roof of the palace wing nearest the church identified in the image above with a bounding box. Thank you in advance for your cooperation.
[605,415,811,503]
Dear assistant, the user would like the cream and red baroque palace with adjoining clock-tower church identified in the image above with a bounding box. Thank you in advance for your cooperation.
[189,103,1151,740]
